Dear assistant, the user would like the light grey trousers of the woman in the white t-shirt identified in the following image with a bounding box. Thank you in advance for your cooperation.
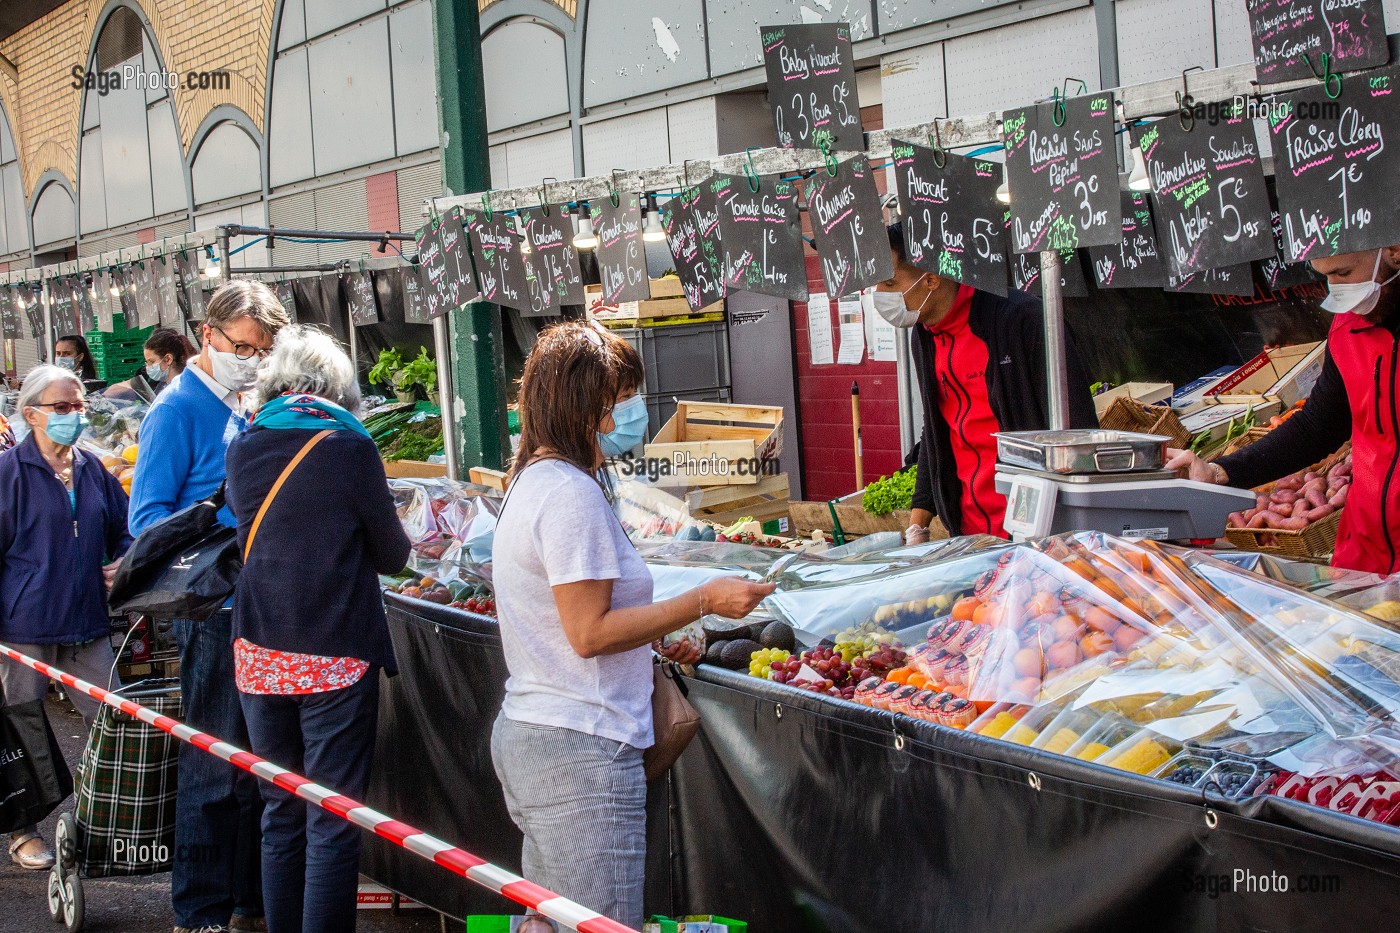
[491,713,647,930]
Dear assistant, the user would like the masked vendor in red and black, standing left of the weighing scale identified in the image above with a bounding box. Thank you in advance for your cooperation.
[871,223,1098,544]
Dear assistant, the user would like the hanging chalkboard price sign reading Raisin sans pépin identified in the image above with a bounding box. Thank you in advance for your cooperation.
[1001,94,1120,252]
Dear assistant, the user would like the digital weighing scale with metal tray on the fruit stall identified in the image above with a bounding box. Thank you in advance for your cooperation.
[997,430,1254,541]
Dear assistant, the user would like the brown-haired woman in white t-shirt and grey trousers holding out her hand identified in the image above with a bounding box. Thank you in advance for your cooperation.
[491,324,773,929]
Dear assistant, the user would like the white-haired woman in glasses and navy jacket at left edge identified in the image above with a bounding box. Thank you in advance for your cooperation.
[0,366,132,870]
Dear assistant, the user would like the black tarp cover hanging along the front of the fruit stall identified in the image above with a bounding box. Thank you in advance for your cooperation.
[361,595,1400,933]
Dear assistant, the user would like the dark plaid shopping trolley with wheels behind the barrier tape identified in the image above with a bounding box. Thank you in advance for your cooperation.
[49,679,183,932]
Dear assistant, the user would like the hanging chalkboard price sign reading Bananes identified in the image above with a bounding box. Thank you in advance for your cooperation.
[806,156,895,297]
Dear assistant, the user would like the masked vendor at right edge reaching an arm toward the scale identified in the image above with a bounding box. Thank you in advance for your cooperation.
[1168,245,1400,574]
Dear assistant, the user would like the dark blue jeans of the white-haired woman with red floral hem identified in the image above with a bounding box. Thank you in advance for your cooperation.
[241,667,379,933]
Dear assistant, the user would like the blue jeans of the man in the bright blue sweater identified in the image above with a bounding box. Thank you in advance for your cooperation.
[171,609,263,929]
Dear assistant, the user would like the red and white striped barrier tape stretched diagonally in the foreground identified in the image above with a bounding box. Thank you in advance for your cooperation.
[0,644,636,933]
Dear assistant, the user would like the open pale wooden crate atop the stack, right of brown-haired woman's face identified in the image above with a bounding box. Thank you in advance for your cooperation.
[643,402,783,486]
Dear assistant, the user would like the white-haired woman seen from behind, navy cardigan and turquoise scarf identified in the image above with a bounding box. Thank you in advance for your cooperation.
[228,325,409,933]
